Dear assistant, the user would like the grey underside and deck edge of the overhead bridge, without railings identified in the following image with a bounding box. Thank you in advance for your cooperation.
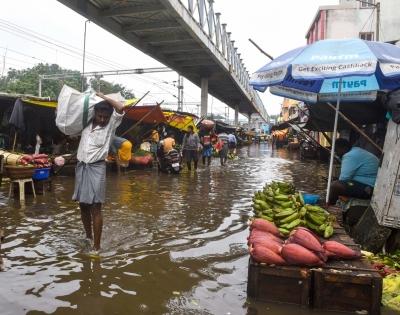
[58,0,257,115]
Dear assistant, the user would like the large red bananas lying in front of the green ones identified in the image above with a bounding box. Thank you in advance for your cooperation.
[248,219,361,267]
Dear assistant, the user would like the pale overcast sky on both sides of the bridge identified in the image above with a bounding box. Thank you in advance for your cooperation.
[0,0,339,119]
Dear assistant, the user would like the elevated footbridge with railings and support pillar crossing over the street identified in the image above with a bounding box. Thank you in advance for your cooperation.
[58,0,268,121]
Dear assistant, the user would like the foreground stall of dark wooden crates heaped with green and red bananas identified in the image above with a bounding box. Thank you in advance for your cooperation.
[247,182,382,314]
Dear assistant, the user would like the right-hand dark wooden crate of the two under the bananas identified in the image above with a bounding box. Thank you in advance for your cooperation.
[312,260,382,314]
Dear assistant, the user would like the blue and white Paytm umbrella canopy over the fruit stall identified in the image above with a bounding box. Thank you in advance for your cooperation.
[250,39,400,103]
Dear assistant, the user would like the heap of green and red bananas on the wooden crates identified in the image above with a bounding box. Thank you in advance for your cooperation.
[247,182,361,267]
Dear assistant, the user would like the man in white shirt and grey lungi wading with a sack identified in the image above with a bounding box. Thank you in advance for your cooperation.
[72,93,124,256]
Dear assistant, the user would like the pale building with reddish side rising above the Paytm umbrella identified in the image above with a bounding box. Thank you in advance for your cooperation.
[306,0,400,44]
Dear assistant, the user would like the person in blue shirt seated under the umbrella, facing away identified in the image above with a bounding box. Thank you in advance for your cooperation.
[329,138,379,205]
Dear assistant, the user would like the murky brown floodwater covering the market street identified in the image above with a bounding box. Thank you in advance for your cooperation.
[0,144,378,315]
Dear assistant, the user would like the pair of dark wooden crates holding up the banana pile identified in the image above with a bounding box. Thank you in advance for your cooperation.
[247,218,382,314]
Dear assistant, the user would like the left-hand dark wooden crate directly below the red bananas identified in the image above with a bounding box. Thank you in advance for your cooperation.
[247,258,312,306]
